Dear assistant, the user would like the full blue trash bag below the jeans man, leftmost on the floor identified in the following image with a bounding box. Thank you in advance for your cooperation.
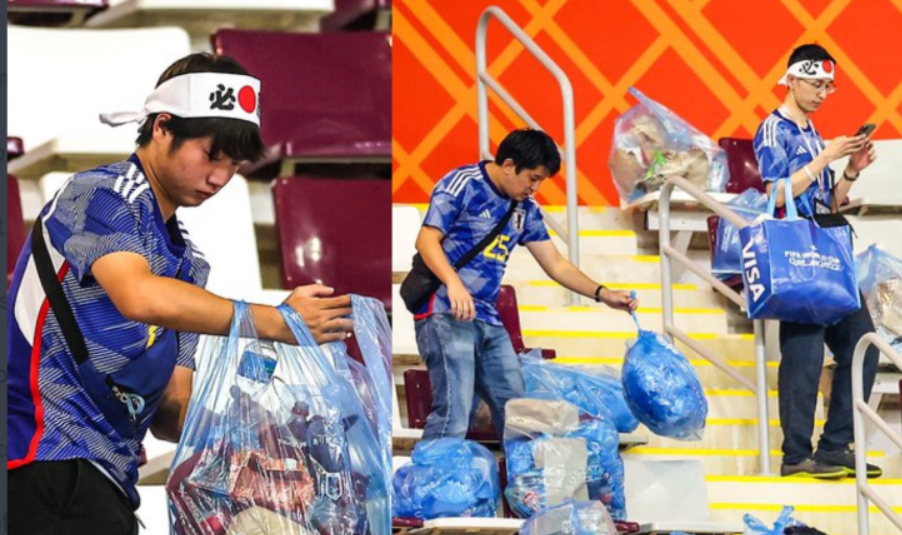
[392,438,501,520]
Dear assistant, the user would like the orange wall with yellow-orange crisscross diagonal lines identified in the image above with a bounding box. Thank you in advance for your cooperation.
[392,0,902,205]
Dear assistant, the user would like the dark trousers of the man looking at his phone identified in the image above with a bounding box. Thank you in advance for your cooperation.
[778,297,880,464]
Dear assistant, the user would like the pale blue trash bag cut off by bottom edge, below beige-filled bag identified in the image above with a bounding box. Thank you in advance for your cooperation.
[520,501,618,535]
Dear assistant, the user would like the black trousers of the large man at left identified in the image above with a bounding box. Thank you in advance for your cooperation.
[7,459,138,535]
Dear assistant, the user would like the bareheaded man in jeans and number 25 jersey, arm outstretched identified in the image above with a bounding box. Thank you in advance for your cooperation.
[414,130,638,439]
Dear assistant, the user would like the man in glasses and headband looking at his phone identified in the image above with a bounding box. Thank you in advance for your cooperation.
[755,45,882,479]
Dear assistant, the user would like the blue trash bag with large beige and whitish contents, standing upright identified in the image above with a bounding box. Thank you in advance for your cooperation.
[504,398,626,520]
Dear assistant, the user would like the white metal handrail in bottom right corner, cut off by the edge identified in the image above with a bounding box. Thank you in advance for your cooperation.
[852,333,902,535]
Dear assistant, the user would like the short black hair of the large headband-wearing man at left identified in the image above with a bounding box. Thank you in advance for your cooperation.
[136,52,265,162]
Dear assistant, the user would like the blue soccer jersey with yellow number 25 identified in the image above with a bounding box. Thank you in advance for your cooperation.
[414,162,549,325]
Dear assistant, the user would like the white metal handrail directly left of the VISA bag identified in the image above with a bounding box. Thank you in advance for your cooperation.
[658,177,770,475]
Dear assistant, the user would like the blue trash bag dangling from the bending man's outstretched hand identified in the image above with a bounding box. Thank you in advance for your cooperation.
[621,313,708,440]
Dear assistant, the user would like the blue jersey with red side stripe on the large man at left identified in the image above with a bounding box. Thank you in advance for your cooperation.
[7,155,209,507]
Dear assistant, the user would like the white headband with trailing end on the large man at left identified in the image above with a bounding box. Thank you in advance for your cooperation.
[100,72,260,126]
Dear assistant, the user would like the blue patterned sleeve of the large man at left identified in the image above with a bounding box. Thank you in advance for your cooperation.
[48,181,150,282]
